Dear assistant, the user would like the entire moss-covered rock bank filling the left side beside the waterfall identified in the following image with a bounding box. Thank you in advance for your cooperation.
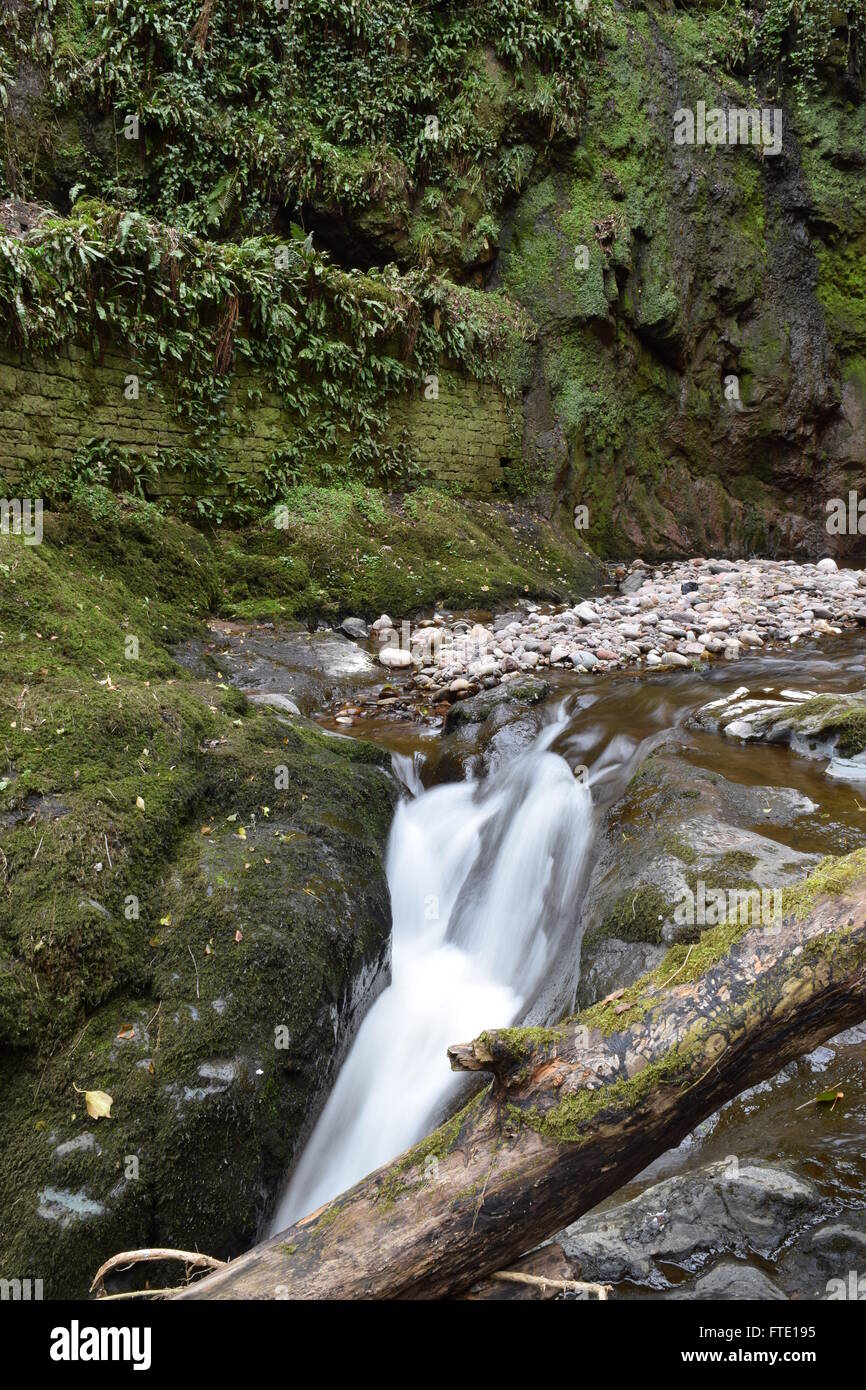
[0,507,396,1298]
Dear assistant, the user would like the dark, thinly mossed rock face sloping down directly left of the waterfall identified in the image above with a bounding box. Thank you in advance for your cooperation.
[0,709,396,1298]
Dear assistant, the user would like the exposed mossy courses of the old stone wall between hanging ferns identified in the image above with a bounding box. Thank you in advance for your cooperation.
[0,343,521,496]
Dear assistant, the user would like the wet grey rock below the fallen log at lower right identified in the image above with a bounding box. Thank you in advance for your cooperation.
[559,1159,822,1287]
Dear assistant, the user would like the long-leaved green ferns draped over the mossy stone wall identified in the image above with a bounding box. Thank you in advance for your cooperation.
[0,203,530,516]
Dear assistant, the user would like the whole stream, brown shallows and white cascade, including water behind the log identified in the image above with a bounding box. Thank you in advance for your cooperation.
[261,635,866,1295]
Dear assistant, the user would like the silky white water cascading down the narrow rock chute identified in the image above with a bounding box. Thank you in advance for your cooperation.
[271,706,592,1232]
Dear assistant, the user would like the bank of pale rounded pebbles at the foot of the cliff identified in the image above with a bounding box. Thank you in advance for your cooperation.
[361,556,866,699]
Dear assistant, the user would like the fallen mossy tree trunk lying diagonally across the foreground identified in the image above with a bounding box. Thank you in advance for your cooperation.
[175,851,866,1298]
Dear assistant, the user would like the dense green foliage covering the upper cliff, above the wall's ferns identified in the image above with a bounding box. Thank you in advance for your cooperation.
[0,0,605,250]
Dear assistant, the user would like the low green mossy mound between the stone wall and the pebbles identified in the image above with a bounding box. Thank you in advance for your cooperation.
[218,487,601,619]
